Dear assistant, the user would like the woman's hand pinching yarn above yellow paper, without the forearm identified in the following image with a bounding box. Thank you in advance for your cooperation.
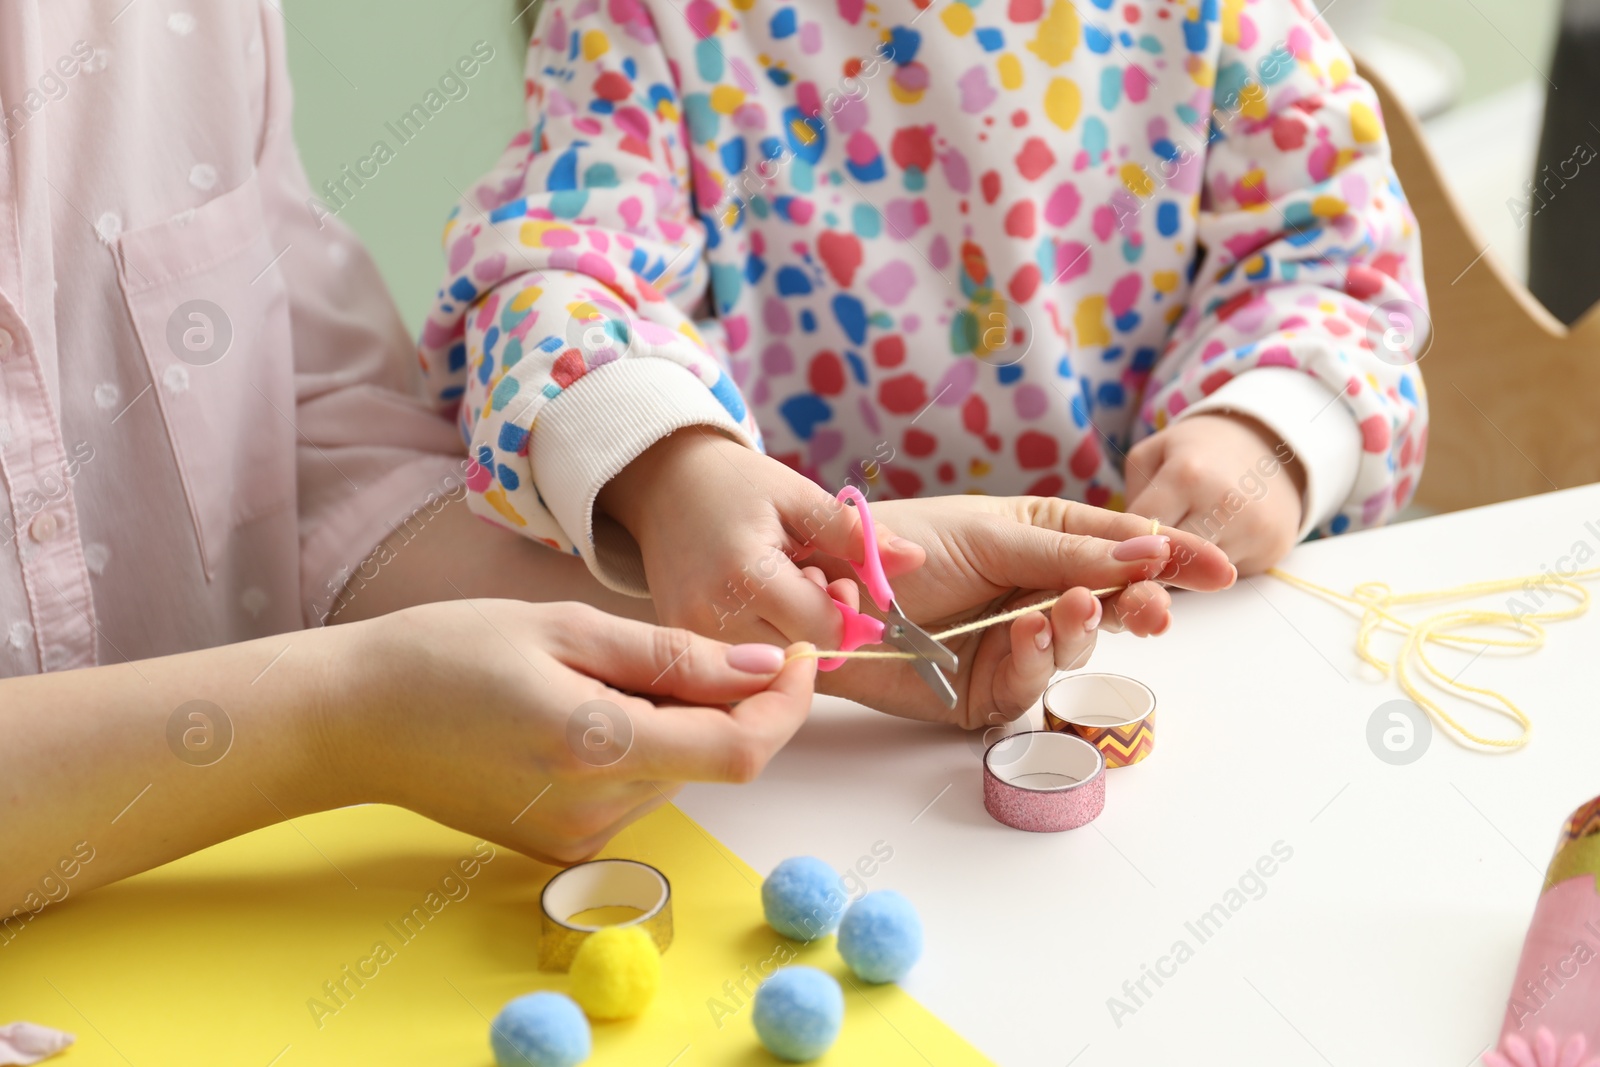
[356,600,816,862]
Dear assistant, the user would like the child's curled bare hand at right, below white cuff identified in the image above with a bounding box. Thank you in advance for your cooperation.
[1128,413,1306,574]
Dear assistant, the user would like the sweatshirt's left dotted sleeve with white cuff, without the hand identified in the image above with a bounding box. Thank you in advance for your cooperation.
[421,0,760,595]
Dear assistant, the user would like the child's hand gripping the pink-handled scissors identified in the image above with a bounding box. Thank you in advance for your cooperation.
[598,427,922,648]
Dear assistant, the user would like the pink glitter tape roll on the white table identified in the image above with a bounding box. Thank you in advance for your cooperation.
[984,729,1106,833]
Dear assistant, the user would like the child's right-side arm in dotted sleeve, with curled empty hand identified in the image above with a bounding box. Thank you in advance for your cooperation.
[1128,0,1427,571]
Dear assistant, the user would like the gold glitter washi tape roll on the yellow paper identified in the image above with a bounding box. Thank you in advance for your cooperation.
[539,859,672,971]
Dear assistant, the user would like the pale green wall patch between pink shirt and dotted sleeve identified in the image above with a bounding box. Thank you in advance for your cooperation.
[283,0,526,333]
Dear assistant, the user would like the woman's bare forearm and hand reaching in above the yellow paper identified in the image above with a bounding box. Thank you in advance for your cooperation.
[0,598,816,921]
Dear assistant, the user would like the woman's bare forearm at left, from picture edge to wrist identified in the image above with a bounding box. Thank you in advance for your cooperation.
[0,625,374,921]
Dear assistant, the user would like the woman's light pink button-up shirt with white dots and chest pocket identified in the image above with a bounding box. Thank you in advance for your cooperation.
[0,0,462,677]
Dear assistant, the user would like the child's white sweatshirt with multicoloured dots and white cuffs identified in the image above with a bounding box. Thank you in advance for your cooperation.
[421,0,1426,593]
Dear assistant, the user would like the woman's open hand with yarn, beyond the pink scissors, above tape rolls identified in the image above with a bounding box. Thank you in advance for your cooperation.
[806,496,1235,728]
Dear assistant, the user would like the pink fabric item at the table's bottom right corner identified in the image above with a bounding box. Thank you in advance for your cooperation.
[1483,875,1600,1067]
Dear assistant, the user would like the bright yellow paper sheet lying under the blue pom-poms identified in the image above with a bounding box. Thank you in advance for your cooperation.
[0,805,989,1067]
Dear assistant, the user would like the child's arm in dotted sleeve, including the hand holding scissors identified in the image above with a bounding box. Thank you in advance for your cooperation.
[422,0,928,659]
